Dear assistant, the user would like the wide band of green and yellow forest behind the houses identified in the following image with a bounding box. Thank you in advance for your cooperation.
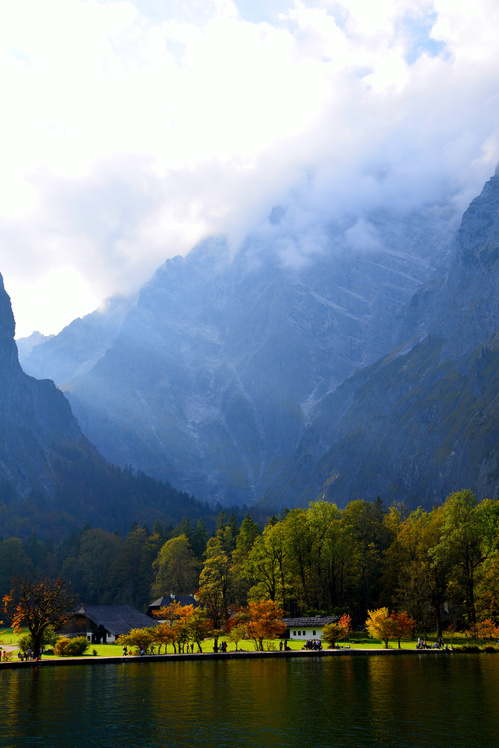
[0,490,499,633]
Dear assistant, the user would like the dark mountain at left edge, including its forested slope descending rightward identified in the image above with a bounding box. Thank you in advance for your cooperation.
[0,275,217,537]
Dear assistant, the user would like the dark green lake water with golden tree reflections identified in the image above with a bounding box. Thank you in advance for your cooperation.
[0,655,499,748]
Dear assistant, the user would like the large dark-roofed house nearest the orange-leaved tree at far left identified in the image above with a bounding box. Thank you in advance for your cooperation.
[60,605,156,644]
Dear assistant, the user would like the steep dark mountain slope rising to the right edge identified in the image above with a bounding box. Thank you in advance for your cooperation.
[268,172,499,507]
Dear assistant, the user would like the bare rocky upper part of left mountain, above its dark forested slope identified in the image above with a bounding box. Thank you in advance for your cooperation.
[0,276,95,497]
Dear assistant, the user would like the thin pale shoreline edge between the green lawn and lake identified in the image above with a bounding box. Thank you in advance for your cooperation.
[0,649,455,670]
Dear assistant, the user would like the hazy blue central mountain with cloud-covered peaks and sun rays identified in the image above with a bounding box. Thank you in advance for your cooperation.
[17,196,457,504]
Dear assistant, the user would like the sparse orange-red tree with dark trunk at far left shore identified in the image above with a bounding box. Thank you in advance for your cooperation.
[3,575,76,658]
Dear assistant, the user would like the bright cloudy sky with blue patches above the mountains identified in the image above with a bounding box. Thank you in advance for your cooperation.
[0,0,499,337]
